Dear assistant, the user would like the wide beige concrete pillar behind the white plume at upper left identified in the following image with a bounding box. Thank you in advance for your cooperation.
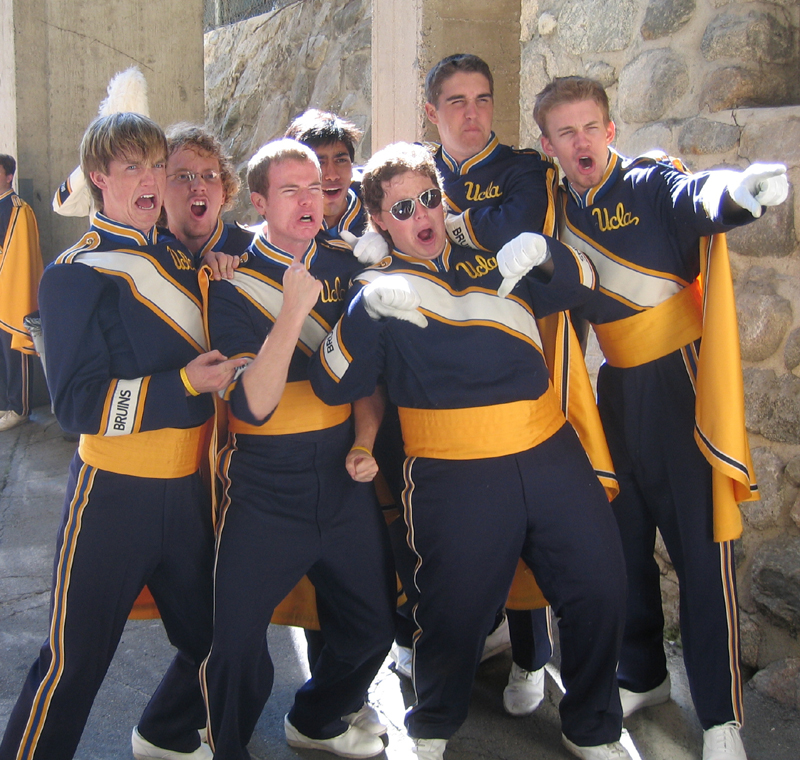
[0,0,204,261]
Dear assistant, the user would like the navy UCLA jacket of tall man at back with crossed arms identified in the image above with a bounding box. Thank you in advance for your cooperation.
[429,133,558,251]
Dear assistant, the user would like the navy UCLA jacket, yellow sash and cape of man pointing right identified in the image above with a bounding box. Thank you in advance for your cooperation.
[558,150,758,541]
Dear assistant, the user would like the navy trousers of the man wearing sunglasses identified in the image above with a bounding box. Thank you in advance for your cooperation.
[404,424,625,746]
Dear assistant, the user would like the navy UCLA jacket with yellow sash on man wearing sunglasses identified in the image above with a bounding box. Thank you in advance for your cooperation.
[311,235,596,459]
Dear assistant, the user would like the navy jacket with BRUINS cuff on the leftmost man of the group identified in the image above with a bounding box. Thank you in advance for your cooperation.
[39,214,213,475]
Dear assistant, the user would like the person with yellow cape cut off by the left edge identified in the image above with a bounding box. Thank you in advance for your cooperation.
[0,154,42,431]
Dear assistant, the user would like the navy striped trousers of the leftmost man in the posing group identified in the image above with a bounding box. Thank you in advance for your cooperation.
[0,453,214,760]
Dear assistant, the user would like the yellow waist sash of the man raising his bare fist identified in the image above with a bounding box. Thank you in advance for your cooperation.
[228,380,350,435]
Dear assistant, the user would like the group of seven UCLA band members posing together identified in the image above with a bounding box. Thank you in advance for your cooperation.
[0,55,788,760]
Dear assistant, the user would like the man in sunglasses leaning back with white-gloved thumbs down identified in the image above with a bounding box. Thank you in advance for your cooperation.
[309,143,629,760]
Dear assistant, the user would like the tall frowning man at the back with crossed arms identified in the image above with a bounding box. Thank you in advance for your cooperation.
[425,53,558,716]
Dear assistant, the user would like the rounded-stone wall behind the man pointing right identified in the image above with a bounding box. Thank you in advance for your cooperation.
[520,0,800,707]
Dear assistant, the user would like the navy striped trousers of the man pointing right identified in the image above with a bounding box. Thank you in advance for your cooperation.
[597,350,742,729]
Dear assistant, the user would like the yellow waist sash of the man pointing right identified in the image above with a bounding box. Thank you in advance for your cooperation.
[592,280,703,369]
